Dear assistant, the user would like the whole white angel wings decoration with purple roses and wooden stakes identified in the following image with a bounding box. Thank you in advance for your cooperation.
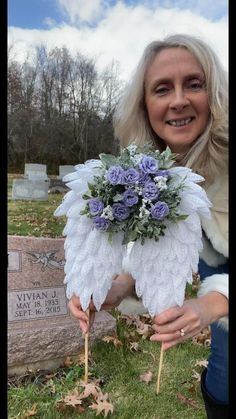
[54,144,211,393]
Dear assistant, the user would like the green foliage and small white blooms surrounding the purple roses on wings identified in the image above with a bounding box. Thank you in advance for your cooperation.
[81,143,186,244]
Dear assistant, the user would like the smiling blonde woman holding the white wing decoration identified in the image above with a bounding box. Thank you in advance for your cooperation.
[69,35,228,419]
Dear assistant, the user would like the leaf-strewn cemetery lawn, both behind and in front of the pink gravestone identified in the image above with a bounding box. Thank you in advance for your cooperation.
[8,175,209,419]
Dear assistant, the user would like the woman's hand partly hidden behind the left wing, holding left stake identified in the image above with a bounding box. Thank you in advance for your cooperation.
[68,274,134,333]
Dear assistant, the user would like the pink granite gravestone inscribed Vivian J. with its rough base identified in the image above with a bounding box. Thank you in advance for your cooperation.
[8,236,116,375]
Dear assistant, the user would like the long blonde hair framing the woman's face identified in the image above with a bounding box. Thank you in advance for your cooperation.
[114,34,228,183]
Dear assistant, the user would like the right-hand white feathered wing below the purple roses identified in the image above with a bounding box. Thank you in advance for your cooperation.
[123,167,211,316]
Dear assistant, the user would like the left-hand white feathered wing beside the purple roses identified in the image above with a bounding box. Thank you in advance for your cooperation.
[54,160,124,311]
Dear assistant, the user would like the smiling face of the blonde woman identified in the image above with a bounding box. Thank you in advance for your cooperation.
[145,48,210,153]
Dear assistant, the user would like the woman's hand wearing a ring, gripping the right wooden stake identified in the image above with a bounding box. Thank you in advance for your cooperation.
[150,291,228,350]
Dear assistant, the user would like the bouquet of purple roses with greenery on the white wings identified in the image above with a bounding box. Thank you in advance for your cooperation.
[81,144,187,244]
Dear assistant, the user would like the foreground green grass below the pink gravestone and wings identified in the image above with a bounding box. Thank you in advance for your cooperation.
[8,319,209,419]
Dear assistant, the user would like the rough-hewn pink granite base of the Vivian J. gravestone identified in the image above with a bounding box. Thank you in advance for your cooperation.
[8,311,116,376]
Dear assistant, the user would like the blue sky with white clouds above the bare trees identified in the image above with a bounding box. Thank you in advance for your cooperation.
[8,0,228,80]
